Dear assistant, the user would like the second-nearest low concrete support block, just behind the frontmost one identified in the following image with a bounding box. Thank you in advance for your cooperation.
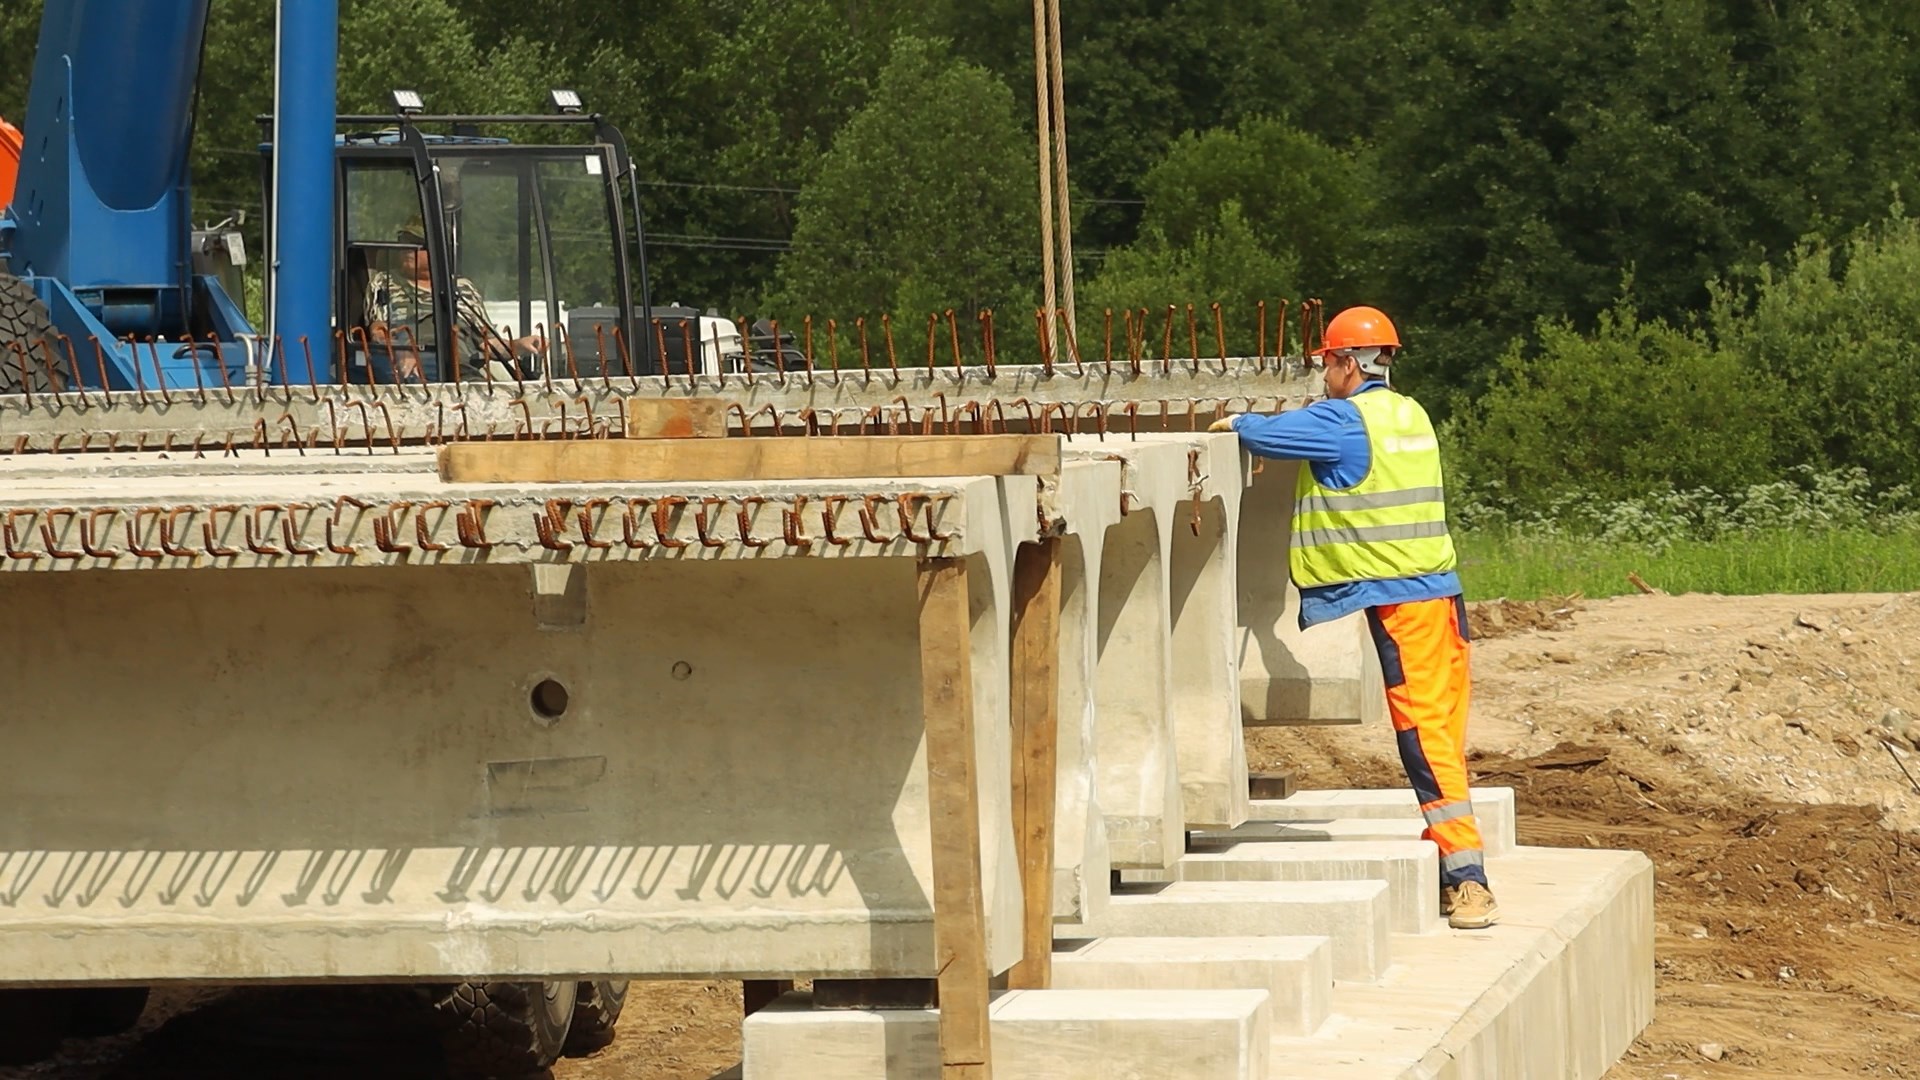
[1054,938,1332,1036]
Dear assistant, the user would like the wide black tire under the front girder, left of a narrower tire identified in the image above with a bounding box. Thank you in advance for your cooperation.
[434,982,580,1080]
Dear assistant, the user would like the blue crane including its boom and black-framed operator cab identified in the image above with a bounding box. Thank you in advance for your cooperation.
[0,0,687,394]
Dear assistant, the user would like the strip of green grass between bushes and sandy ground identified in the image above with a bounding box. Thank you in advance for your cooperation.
[1455,528,1920,600]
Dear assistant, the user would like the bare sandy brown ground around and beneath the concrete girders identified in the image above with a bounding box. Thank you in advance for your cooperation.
[11,596,1920,1080]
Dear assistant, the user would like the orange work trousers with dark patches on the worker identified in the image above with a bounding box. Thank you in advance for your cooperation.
[1367,596,1486,886]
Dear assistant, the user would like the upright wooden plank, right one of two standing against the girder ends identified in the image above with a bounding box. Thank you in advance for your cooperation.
[1006,536,1060,990]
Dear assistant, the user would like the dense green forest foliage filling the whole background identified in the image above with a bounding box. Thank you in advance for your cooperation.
[0,0,1920,505]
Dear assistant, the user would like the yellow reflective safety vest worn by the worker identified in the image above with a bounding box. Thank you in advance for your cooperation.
[1288,388,1455,588]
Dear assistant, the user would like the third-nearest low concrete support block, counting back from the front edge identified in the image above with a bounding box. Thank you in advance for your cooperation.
[1056,882,1392,980]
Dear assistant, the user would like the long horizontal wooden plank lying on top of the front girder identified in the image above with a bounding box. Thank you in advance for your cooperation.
[440,434,1060,484]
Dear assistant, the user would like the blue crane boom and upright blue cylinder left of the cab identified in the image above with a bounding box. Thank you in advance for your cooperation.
[0,0,338,388]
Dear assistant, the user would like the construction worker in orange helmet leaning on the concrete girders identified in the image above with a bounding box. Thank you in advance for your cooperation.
[1210,307,1500,930]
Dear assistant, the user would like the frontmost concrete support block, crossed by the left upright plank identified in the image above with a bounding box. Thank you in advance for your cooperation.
[741,990,1273,1080]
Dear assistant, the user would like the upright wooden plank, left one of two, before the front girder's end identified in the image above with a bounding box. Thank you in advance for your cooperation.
[920,559,993,1080]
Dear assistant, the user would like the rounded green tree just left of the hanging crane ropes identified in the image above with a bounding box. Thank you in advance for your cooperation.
[776,37,1039,336]
